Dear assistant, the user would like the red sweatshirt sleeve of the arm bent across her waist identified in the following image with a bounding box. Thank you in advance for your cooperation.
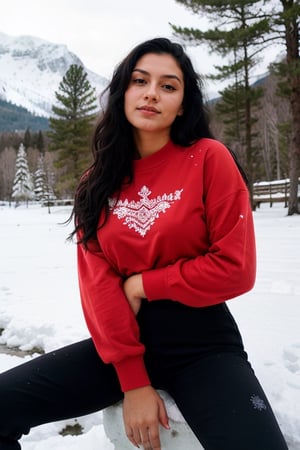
[142,143,256,307]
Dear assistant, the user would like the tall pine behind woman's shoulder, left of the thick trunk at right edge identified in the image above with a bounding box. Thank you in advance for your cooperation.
[172,0,270,205]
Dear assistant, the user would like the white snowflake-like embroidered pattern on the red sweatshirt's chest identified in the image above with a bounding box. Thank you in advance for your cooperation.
[109,186,183,237]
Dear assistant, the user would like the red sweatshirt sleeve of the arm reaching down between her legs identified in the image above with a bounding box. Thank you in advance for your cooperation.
[77,240,150,391]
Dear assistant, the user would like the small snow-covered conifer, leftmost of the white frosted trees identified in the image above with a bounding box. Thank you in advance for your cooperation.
[12,143,34,205]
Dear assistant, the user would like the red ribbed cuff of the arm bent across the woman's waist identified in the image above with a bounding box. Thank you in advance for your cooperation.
[142,267,170,301]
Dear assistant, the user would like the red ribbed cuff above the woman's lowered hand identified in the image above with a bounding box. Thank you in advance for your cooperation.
[114,356,151,392]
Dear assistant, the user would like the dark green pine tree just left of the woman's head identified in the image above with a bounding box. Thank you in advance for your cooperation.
[49,64,96,196]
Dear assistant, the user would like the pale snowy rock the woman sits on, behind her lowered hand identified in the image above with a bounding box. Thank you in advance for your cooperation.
[103,391,203,450]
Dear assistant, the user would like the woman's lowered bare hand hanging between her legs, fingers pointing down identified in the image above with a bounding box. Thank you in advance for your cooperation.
[123,386,170,450]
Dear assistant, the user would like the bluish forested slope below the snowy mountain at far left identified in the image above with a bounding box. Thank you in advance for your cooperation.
[0,99,49,132]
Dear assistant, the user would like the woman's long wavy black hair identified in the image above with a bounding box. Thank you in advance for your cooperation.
[71,38,213,246]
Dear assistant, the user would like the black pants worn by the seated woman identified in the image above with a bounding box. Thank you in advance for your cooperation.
[0,300,287,450]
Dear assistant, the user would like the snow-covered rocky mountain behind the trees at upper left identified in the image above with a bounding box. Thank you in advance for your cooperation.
[0,32,107,117]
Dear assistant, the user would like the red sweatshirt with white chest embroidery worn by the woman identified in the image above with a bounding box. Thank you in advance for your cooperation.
[78,139,256,391]
